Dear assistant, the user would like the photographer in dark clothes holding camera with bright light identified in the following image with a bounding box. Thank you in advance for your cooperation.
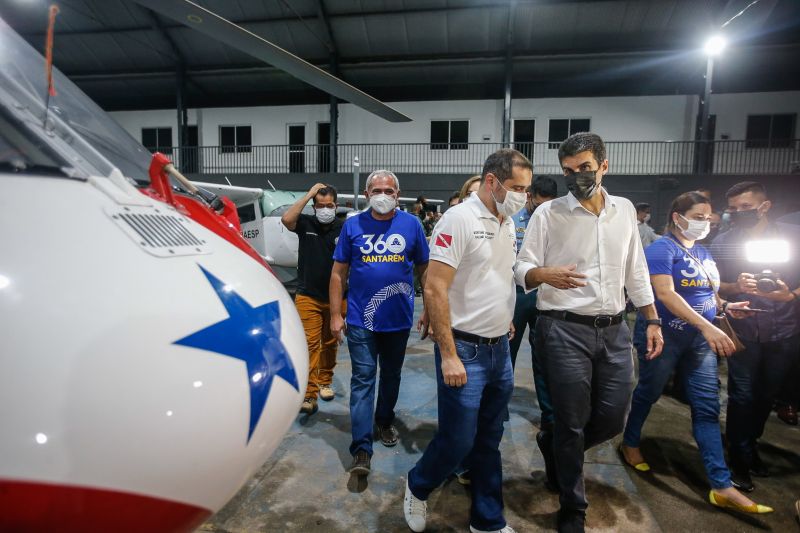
[711,181,800,492]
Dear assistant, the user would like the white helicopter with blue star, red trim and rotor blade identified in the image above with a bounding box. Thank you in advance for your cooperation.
[0,0,405,532]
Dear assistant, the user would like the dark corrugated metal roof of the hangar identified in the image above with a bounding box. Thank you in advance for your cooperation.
[0,0,800,109]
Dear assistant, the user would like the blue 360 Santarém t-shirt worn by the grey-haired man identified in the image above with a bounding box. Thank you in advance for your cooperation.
[333,209,428,331]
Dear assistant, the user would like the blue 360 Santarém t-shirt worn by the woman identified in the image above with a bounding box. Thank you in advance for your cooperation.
[644,235,719,332]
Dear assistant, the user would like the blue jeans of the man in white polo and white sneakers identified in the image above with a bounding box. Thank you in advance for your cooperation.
[408,337,514,531]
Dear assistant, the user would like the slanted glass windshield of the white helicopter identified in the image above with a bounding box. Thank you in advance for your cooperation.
[0,19,151,183]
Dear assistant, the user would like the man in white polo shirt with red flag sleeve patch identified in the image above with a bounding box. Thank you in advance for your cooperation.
[403,148,532,533]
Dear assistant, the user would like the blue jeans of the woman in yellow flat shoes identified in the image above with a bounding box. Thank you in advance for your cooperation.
[622,326,736,489]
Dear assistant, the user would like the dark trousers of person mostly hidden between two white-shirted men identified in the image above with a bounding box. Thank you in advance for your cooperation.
[511,285,553,429]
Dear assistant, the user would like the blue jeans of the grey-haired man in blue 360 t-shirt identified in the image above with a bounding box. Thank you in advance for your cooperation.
[347,324,410,456]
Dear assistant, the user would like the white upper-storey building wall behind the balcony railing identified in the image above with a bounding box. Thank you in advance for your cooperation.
[111,91,800,173]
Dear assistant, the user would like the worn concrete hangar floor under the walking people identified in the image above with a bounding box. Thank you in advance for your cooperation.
[198,302,800,533]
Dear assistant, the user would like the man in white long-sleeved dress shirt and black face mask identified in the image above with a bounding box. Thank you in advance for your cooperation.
[515,133,664,532]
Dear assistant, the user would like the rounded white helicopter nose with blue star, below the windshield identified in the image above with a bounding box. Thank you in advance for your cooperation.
[0,174,308,530]
